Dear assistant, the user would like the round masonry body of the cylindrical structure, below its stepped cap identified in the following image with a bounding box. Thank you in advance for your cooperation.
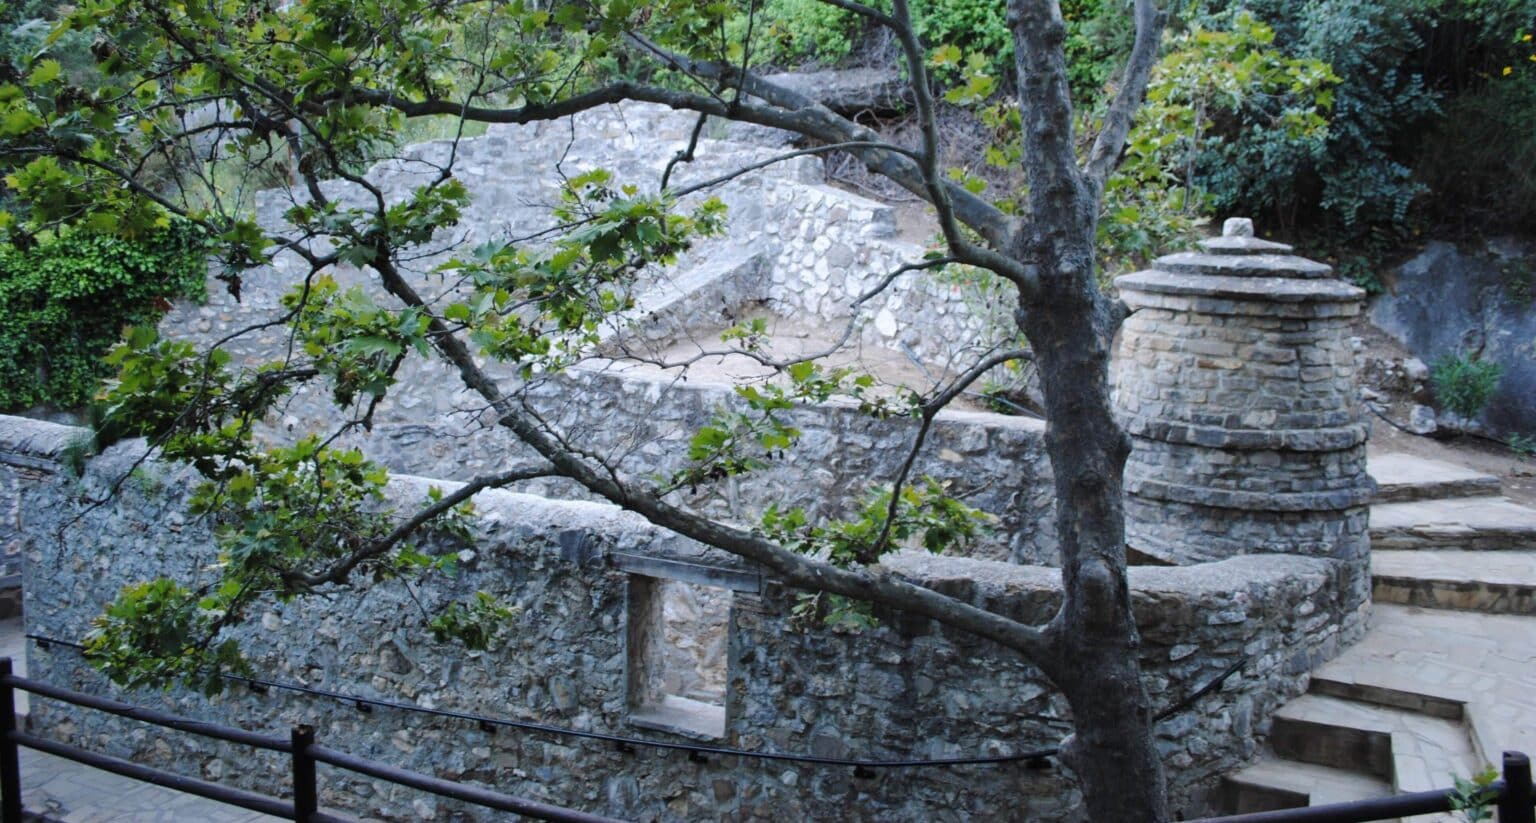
[1117,296,1367,562]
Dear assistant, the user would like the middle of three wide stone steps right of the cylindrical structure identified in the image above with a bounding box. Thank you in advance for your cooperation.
[1370,497,1536,551]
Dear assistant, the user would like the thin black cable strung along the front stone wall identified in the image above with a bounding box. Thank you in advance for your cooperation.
[26,634,1249,769]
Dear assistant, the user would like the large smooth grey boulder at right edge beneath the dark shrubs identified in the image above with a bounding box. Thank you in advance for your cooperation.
[1370,240,1536,435]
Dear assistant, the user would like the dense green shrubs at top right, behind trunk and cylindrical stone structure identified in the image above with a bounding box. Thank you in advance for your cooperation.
[734,0,1536,287]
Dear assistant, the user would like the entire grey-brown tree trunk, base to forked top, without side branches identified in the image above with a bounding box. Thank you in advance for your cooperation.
[1008,0,1167,823]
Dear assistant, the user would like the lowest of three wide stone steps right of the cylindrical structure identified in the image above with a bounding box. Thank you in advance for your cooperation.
[1370,550,1536,616]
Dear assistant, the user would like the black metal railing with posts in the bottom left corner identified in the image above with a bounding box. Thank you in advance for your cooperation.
[0,657,616,823]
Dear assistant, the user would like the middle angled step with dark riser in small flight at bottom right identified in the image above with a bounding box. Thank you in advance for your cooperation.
[1270,694,1484,792]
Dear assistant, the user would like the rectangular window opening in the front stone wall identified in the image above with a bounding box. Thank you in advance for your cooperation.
[627,574,731,740]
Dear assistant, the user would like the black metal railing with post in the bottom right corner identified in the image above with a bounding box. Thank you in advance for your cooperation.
[1192,751,1536,823]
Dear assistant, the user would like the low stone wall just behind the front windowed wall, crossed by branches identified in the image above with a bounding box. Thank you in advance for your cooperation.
[352,369,1057,564]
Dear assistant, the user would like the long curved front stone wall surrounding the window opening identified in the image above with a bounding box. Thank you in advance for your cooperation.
[9,418,1339,821]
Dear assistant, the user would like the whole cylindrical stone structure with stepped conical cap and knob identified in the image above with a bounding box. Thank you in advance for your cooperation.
[1114,218,1373,608]
